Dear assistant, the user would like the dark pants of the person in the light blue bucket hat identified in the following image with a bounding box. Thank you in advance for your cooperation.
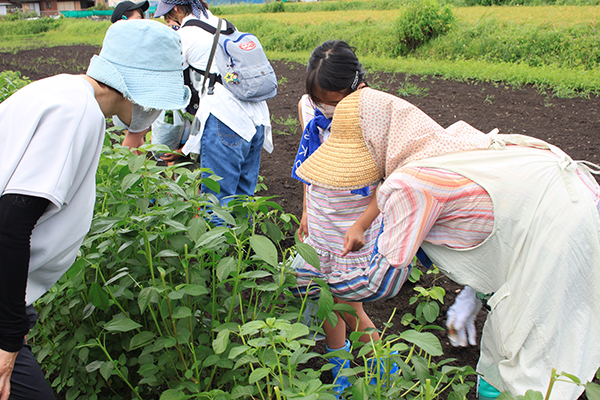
[8,306,56,400]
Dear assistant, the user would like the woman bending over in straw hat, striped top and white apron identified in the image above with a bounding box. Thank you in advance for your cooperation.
[297,88,600,400]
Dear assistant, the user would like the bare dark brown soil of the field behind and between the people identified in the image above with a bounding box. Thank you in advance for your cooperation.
[0,46,600,399]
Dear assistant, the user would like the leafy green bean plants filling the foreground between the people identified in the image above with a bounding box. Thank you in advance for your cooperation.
[23,129,474,400]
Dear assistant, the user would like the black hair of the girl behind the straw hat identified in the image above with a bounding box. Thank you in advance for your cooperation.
[305,40,365,102]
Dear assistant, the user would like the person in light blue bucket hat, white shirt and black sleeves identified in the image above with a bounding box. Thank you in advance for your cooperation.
[0,20,190,400]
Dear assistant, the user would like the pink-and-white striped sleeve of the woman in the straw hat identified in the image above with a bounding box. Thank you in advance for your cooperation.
[377,168,494,268]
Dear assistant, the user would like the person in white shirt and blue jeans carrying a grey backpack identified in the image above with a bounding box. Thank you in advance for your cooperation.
[154,0,273,204]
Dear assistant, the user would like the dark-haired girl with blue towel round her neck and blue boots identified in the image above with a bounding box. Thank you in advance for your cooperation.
[292,41,398,395]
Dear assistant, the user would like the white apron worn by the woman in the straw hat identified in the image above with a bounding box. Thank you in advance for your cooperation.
[406,135,600,400]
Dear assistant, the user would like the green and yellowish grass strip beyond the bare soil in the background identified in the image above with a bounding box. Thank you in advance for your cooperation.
[0,4,600,96]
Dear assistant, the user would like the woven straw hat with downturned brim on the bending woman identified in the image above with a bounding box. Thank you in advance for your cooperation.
[296,90,382,190]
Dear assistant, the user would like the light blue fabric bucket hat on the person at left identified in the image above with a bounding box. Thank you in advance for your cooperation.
[86,20,191,110]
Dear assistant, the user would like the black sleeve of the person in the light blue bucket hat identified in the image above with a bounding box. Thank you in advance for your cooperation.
[0,194,50,352]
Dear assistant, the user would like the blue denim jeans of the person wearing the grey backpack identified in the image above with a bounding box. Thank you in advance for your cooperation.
[200,114,265,204]
